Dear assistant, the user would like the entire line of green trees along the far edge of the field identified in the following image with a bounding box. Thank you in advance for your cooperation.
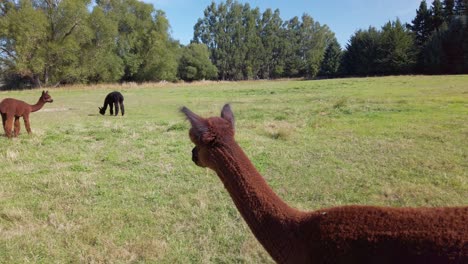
[0,0,468,89]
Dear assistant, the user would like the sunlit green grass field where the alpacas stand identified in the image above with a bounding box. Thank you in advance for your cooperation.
[0,76,468,263]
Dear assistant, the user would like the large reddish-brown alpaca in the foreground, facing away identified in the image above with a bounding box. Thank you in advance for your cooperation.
[181,105,468,264]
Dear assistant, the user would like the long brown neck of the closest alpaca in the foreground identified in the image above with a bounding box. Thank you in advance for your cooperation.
[211,141,305,262]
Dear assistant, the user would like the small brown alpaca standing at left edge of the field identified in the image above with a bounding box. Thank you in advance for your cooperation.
[0,91,54,138]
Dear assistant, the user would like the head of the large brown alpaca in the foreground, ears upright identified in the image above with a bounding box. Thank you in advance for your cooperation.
[181,104,234,169]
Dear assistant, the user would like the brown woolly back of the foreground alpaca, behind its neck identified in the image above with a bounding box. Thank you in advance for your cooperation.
[303,206,468,263]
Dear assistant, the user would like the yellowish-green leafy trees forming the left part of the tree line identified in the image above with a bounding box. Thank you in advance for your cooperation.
[0,0,181,86]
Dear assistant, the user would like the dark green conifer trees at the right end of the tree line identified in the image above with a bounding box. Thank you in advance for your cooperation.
[340,0,468,76]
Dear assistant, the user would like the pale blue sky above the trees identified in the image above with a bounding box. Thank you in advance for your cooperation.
[143,0,424,47]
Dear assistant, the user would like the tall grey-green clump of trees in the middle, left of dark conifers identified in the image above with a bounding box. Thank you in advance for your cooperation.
[193,0,334,80]
